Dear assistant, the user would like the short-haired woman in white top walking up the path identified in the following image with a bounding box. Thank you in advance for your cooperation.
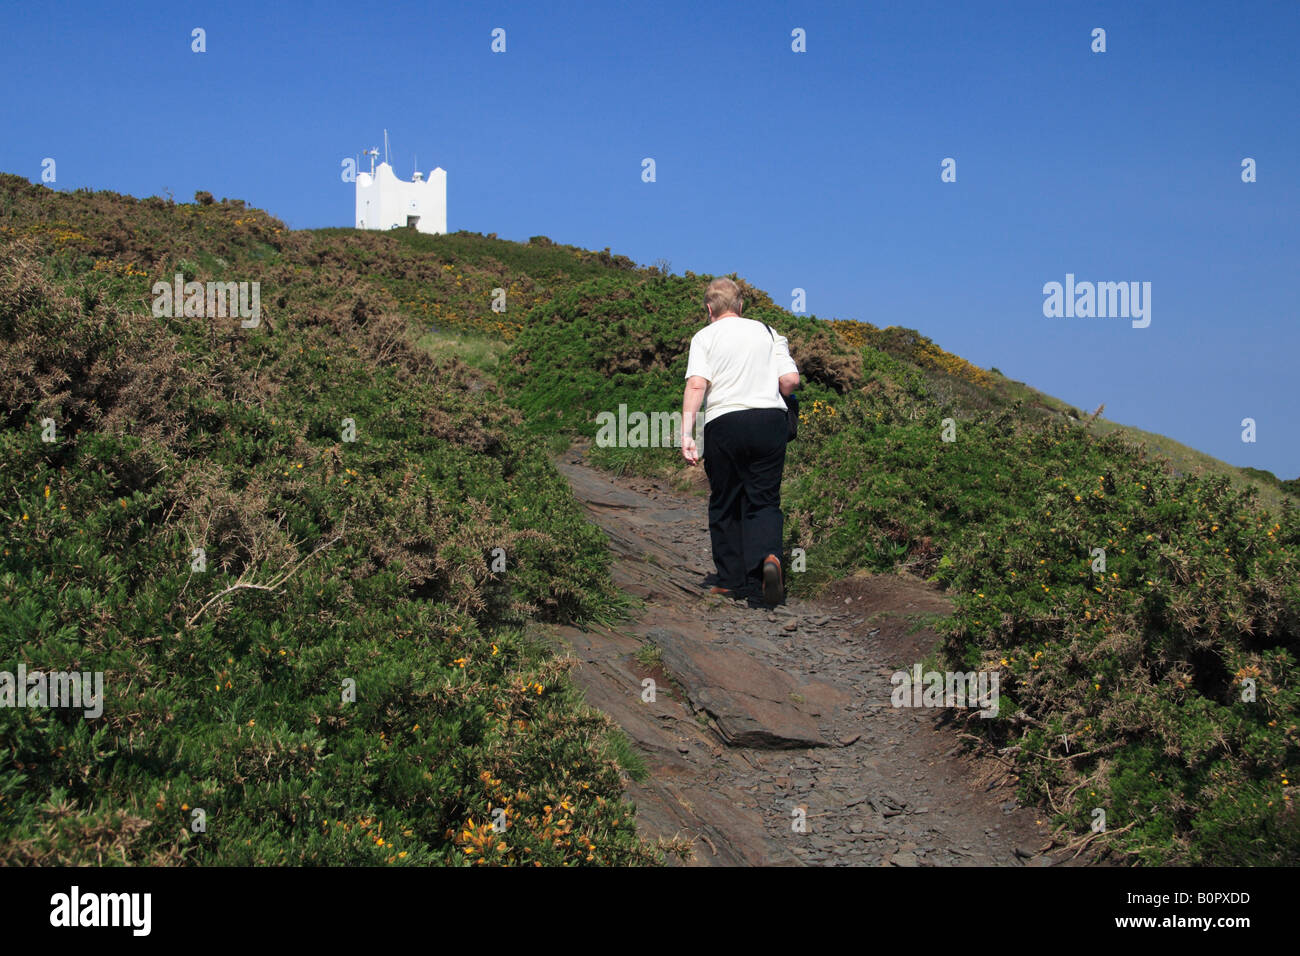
[681,278,800,605]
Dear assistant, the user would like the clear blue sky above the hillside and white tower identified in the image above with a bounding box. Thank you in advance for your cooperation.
[0,0,1300,477]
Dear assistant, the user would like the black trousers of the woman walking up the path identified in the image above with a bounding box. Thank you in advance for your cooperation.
[703,408,787,591]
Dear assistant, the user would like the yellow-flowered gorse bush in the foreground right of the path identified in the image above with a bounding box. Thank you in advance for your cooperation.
[941,437,1300,864]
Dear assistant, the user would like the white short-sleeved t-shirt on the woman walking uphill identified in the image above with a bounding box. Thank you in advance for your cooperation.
[686,315,800,425]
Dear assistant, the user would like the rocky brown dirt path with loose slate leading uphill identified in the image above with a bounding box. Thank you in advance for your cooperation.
[553,447,1081,866]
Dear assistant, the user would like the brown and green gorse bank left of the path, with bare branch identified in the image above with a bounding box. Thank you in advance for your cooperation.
[0,177,660,865]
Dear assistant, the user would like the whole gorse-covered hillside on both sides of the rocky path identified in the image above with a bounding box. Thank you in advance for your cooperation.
[0,176,1300,864]
